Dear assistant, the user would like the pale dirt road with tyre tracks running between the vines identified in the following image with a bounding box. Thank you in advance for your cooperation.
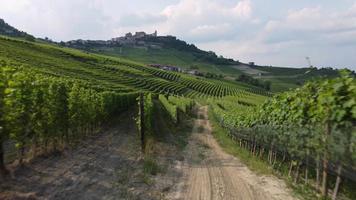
[167,106,295,200]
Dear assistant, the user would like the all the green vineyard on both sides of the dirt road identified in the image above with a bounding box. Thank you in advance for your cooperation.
[0,36,356,199]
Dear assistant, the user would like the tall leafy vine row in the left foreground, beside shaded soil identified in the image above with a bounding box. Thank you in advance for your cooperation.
[1,68,137,158]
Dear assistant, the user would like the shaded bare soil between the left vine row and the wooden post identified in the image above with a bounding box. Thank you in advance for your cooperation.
[0,112,162,200]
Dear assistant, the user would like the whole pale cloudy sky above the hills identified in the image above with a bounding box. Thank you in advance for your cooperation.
[0,0,356,70]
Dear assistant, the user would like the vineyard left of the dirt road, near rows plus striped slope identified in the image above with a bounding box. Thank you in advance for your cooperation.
[0,36,264,175]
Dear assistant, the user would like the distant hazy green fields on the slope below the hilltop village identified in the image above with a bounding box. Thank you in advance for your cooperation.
[76,46,337,92]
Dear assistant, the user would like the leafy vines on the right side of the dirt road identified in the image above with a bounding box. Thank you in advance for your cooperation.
[211,72,356,199]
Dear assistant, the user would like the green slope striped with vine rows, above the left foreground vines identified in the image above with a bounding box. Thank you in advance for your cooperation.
[0,37,268,97]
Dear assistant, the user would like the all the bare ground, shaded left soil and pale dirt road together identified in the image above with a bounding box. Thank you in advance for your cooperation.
[0,107,295,200]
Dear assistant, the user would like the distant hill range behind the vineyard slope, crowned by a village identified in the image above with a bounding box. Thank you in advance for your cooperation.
[0,19,338,92]
